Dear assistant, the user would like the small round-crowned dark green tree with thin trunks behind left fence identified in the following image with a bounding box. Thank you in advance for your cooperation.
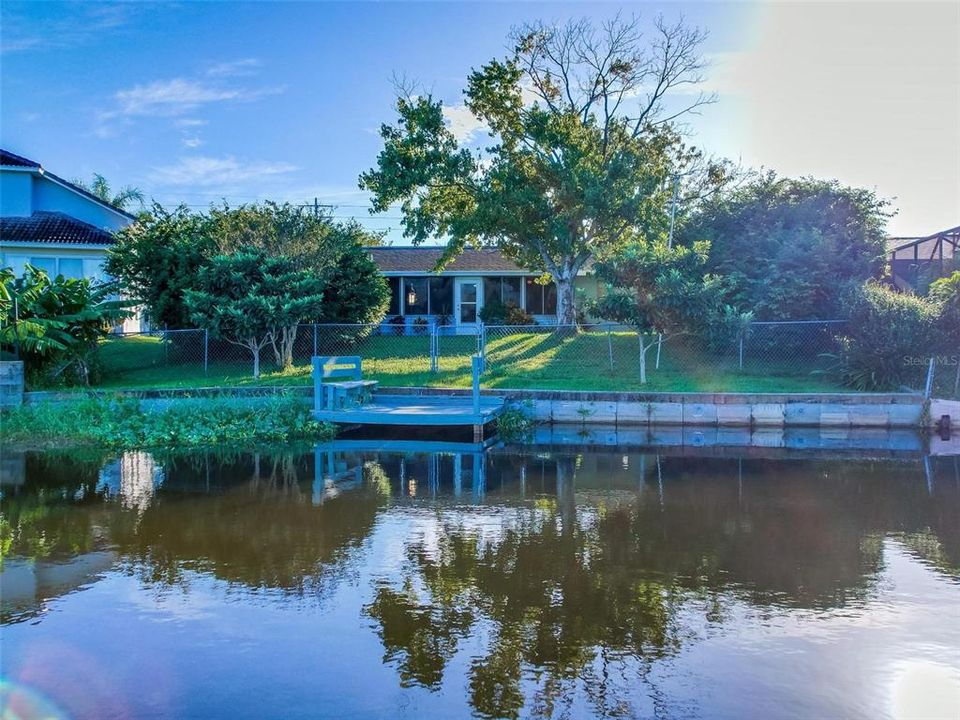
[184,249,323,377]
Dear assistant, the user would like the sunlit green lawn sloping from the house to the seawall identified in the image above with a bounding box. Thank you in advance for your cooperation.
[92,332,841,392]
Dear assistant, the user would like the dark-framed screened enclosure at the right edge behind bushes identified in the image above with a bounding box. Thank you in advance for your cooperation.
[887,226,960,294]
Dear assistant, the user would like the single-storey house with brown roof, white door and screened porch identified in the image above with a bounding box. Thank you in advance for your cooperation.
[369,245,596,332]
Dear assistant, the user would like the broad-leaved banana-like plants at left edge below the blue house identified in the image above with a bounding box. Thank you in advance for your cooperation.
[0,266,131,385]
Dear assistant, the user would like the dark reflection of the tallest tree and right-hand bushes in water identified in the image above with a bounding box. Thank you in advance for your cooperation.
[366,453,957,717]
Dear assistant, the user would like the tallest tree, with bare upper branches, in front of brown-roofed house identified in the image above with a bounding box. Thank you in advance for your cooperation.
[360,17,723,323]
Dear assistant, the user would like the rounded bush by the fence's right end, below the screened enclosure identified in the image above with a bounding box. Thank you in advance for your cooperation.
[839,282,940,390]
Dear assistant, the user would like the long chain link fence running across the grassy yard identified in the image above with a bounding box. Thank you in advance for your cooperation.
[90,320,924,397]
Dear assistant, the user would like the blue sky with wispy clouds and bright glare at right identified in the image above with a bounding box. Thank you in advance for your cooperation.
[0,0,960,242]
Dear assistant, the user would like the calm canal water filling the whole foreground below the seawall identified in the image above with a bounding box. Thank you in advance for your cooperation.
[0,447,960,719]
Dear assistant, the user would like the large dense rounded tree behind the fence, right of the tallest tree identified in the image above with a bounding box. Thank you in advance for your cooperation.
[678,172,889,320]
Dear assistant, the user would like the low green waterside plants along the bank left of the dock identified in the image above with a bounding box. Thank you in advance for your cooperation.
[2,397,333,448]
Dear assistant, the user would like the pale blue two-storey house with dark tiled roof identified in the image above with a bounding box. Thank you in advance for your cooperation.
[0,150,139,330]
